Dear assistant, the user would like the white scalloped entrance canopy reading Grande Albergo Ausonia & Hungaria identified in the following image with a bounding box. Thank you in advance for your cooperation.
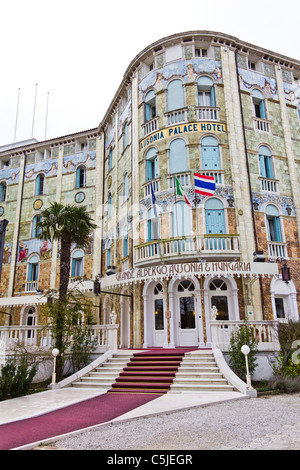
[101,261,278,289]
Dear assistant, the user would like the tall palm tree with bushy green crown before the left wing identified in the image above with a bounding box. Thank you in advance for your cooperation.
[38,202,97,300]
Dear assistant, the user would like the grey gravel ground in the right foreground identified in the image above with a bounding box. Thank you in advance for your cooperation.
[40,393,300,450]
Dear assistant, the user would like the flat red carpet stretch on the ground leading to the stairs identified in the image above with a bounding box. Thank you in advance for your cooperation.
[0,393,161,450]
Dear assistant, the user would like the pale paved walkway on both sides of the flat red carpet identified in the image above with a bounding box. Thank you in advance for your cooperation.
[0,388,246,449]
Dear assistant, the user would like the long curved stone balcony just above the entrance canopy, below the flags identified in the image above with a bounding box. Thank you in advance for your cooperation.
[135,234,240,266]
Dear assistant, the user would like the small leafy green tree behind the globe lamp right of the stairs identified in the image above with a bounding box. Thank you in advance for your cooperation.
[229,320,257,380]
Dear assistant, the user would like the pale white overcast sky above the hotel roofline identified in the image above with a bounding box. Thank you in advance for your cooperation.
[0,0,300,146]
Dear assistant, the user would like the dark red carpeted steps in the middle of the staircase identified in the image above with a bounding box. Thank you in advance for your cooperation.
[108,351,184,394]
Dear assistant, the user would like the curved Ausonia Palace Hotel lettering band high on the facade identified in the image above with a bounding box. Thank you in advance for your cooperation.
[140,122,226,150]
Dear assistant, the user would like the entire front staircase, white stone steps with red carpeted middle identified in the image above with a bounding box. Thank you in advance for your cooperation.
[71,349,236,394]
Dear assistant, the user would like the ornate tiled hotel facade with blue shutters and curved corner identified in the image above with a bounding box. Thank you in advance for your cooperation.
[0,31,300,347]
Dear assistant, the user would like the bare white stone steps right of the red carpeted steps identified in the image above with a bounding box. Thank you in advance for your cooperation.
[170,350,235,393]
